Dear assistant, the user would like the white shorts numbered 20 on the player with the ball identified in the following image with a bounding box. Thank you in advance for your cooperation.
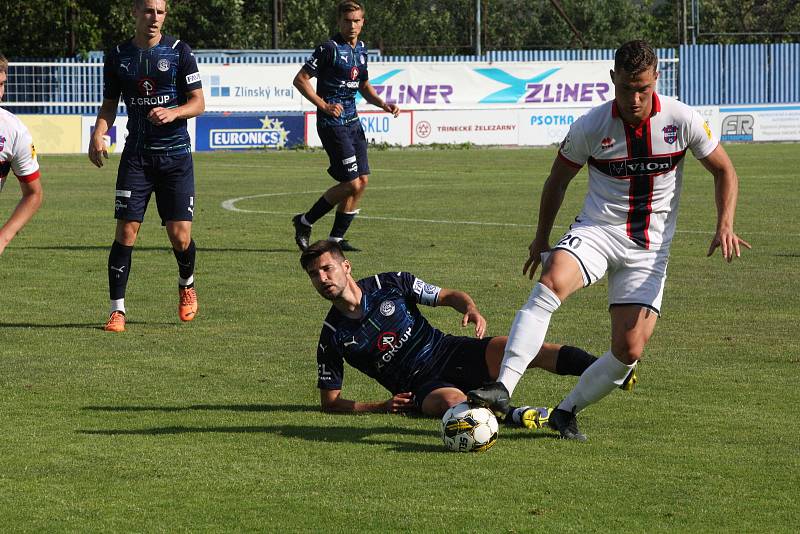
[553,222,669,315]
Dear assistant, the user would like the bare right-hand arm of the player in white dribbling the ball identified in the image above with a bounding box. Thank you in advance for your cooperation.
[700,144,751,262]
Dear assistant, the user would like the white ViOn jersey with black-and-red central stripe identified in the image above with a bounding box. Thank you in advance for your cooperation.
[558,93,718,250]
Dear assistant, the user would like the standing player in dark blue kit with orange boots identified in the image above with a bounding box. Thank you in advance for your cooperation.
[89,0,205,332]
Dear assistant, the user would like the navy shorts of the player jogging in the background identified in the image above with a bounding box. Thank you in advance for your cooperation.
[317,120,369,182]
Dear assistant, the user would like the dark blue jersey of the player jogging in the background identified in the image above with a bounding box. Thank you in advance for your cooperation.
[303,34,369,126]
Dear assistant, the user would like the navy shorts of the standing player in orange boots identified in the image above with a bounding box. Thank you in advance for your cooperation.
[114,152,194,224]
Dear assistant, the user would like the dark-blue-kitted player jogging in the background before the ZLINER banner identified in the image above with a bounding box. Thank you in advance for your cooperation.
[292,0,400,251]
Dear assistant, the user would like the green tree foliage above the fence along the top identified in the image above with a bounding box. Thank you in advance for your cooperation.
[0,0,800,58]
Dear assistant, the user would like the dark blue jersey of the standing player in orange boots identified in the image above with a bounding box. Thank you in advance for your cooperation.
[103,35,202,154]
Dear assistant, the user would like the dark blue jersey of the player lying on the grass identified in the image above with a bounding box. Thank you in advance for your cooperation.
[317,273,449,394]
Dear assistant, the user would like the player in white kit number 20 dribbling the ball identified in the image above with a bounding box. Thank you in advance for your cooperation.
[468,36,750,441]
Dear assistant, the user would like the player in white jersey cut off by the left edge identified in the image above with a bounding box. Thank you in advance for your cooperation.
[0,53,42,255]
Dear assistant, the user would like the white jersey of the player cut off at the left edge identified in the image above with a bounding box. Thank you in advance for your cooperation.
[0,108,39,194]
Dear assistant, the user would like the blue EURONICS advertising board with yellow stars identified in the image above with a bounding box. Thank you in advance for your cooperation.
[194,113,304,151]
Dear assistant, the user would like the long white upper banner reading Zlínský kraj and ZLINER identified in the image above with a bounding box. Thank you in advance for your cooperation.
[202,61,614,111]
